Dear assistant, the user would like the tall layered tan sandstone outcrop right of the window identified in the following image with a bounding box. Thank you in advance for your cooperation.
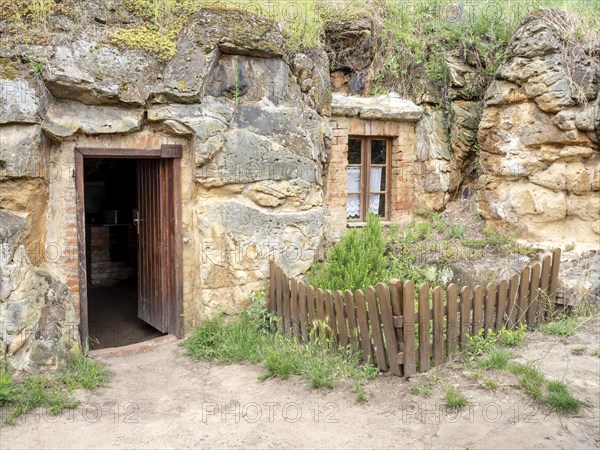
[478,16,600,242]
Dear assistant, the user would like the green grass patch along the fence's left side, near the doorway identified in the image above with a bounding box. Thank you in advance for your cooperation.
[182,295,379,398]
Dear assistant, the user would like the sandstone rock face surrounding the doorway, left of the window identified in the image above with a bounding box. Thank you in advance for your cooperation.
[0,0,330,370]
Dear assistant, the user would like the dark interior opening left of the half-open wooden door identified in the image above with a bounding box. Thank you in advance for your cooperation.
[84,158,163,348]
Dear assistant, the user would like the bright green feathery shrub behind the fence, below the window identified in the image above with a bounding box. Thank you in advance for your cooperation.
[307,214,388,291]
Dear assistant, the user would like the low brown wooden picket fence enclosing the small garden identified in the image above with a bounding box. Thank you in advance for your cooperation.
[268,249,560,376]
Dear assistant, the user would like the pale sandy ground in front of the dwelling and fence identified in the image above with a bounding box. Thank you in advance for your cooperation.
[0,319,600,450]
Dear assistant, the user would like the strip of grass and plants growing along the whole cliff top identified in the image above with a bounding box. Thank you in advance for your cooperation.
[0,0,600,70]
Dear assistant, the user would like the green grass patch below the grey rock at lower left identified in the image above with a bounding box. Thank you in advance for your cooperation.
[0,356,110,424]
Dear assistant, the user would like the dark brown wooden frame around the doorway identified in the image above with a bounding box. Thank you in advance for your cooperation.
[75,144,183,342]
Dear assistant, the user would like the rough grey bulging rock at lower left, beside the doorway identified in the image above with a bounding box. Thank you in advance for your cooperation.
[0,210,79,371]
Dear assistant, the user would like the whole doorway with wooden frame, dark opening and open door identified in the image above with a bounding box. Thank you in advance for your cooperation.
[75,146,182,348]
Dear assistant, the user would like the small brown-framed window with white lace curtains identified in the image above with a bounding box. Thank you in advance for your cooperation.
[346,136,392,221]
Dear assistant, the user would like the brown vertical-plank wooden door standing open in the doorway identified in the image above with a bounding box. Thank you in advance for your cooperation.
[136,159,181,335]
